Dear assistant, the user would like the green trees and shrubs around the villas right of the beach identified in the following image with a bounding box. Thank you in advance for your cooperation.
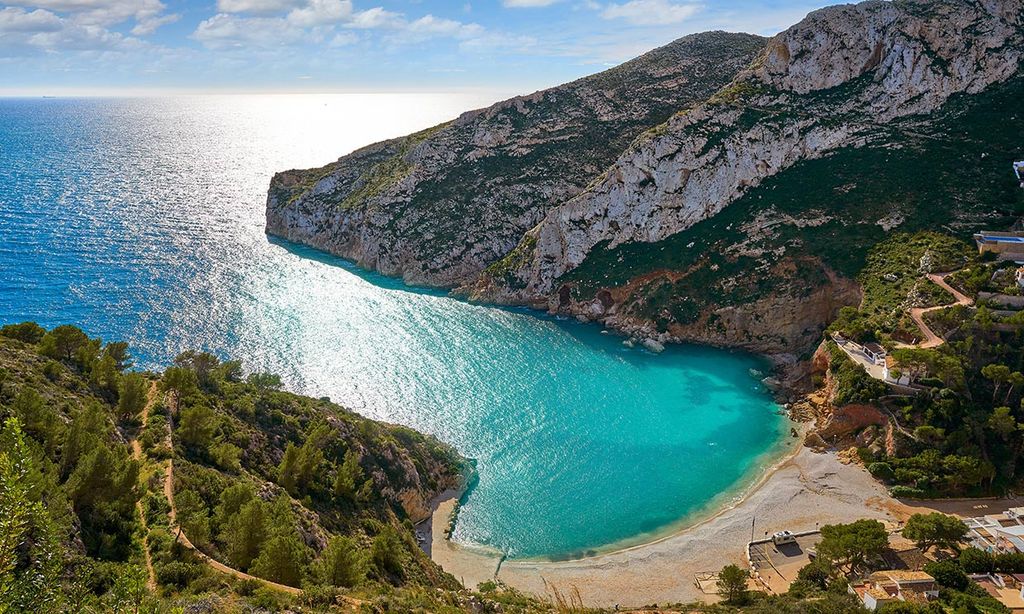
[828,226,1024,498]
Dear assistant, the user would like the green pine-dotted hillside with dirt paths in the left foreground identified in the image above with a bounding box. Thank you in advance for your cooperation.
[0,323,520,612]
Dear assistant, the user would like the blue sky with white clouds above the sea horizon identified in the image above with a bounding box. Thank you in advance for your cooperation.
[0,0,828,94]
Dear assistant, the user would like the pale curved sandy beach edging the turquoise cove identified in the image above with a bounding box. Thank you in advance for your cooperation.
[431,448,912,607]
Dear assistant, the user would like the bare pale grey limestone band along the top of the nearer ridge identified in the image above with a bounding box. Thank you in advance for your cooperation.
[487,0,1024,302]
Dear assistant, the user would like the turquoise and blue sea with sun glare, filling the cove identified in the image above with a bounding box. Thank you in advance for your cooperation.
[0,95,783,557]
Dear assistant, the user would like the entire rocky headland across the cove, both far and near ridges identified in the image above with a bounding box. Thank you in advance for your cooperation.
[267,0,1024,357]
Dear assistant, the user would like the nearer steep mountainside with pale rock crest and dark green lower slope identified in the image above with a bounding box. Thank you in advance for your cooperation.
[472,0,1022,352]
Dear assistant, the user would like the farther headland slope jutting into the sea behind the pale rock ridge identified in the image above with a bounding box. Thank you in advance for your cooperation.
[266,33,764,286]
